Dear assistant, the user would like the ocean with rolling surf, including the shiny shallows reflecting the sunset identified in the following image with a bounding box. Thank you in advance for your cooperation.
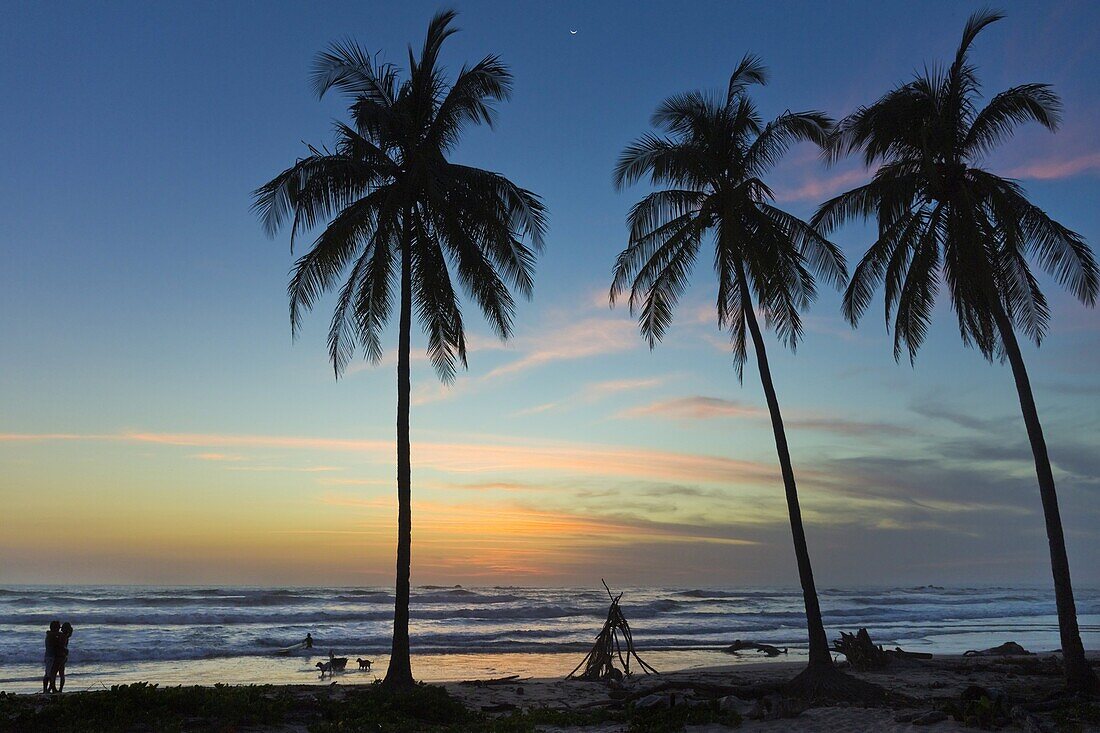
[0,586,1100,692]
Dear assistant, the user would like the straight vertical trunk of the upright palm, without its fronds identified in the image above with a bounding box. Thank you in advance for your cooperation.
[385,223,414,687]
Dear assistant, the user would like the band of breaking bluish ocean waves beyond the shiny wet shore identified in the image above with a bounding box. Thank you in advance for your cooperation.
[0,586,1100,669]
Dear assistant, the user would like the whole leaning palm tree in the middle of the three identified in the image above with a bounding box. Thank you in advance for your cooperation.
[611,55,875,696]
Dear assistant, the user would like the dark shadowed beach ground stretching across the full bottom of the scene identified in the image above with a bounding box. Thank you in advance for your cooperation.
[0,652,1100,733]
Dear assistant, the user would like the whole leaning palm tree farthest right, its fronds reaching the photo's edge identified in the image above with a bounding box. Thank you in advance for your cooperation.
[813,11,1100,690]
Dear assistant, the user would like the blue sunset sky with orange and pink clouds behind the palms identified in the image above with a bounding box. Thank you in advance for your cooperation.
[0,0,1100,588]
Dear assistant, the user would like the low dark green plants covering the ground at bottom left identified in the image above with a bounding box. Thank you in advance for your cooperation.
[0,682,740,733]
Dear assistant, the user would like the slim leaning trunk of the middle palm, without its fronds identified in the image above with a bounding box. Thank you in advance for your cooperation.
[738,273,833,667]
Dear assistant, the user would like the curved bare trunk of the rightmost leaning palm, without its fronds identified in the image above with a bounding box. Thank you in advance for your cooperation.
[989,294,1098,691]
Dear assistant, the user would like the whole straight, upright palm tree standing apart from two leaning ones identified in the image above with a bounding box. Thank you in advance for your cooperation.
[254,11,547,687]
